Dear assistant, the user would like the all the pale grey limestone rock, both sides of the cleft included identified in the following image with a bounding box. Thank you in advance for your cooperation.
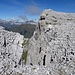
[0,9,75,75]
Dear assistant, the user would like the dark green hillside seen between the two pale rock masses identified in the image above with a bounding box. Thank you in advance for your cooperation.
[8,24,36,38]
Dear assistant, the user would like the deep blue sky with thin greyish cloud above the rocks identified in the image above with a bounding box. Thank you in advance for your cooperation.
[0,0,75,20]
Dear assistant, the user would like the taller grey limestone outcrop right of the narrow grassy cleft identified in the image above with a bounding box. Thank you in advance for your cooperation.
[27,10,75,75]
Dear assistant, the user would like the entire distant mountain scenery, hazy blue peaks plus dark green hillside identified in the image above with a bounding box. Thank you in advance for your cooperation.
[0,19,36,38]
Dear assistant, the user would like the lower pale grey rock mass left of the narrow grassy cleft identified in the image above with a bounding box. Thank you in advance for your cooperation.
[0,27,23,75]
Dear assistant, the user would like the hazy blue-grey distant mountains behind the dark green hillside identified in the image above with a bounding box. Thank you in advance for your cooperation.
[0,19,36,29]
